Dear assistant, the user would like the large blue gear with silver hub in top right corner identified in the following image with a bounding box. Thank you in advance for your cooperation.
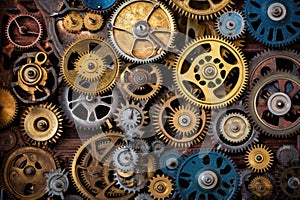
[244,0,300,47]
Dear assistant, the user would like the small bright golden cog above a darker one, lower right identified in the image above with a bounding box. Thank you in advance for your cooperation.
[245,144,274,173]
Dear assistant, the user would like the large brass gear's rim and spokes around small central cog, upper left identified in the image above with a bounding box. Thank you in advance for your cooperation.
[61,38,121,95]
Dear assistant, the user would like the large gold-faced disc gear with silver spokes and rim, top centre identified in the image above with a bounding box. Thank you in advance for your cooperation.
[109,0,175,63]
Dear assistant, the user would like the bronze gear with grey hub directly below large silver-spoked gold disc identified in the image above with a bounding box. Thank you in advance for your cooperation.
[120,63,164,101]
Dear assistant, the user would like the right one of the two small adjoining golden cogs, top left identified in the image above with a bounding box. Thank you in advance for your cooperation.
[83,12,103,31]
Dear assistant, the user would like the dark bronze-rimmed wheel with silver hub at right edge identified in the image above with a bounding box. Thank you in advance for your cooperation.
[248,72,300,137]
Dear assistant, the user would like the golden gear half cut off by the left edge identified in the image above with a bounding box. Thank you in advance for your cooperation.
[0,88,18,128]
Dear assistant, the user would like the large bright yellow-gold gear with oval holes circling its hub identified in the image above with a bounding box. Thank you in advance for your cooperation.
[174,37,248,108]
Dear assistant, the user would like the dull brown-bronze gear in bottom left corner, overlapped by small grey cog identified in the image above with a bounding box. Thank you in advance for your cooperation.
[3,147,59,200]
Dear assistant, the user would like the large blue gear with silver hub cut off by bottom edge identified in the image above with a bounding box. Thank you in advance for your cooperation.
[175,150,240,200]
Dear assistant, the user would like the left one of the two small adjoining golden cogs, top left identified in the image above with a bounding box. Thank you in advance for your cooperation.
[63,11,83,33]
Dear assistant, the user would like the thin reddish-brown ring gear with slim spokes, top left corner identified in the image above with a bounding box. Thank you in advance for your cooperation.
[5,14,43,49]
